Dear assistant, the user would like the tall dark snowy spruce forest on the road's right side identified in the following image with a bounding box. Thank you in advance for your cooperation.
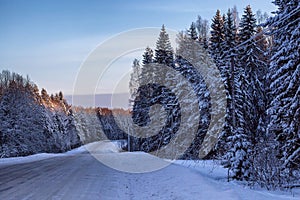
[129,0,300,189]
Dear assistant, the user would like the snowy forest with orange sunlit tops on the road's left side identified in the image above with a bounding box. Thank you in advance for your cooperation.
[0,71,129,158]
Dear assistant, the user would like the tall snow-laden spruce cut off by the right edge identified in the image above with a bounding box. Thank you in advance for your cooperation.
[267,0,300,180]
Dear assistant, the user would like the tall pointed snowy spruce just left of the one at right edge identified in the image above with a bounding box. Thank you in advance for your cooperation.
[229,6,267,180]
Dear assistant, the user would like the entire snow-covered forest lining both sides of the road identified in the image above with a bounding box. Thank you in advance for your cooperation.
[0,0,300,189]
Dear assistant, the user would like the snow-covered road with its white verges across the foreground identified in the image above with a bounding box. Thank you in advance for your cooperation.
[0,142,299,200]
